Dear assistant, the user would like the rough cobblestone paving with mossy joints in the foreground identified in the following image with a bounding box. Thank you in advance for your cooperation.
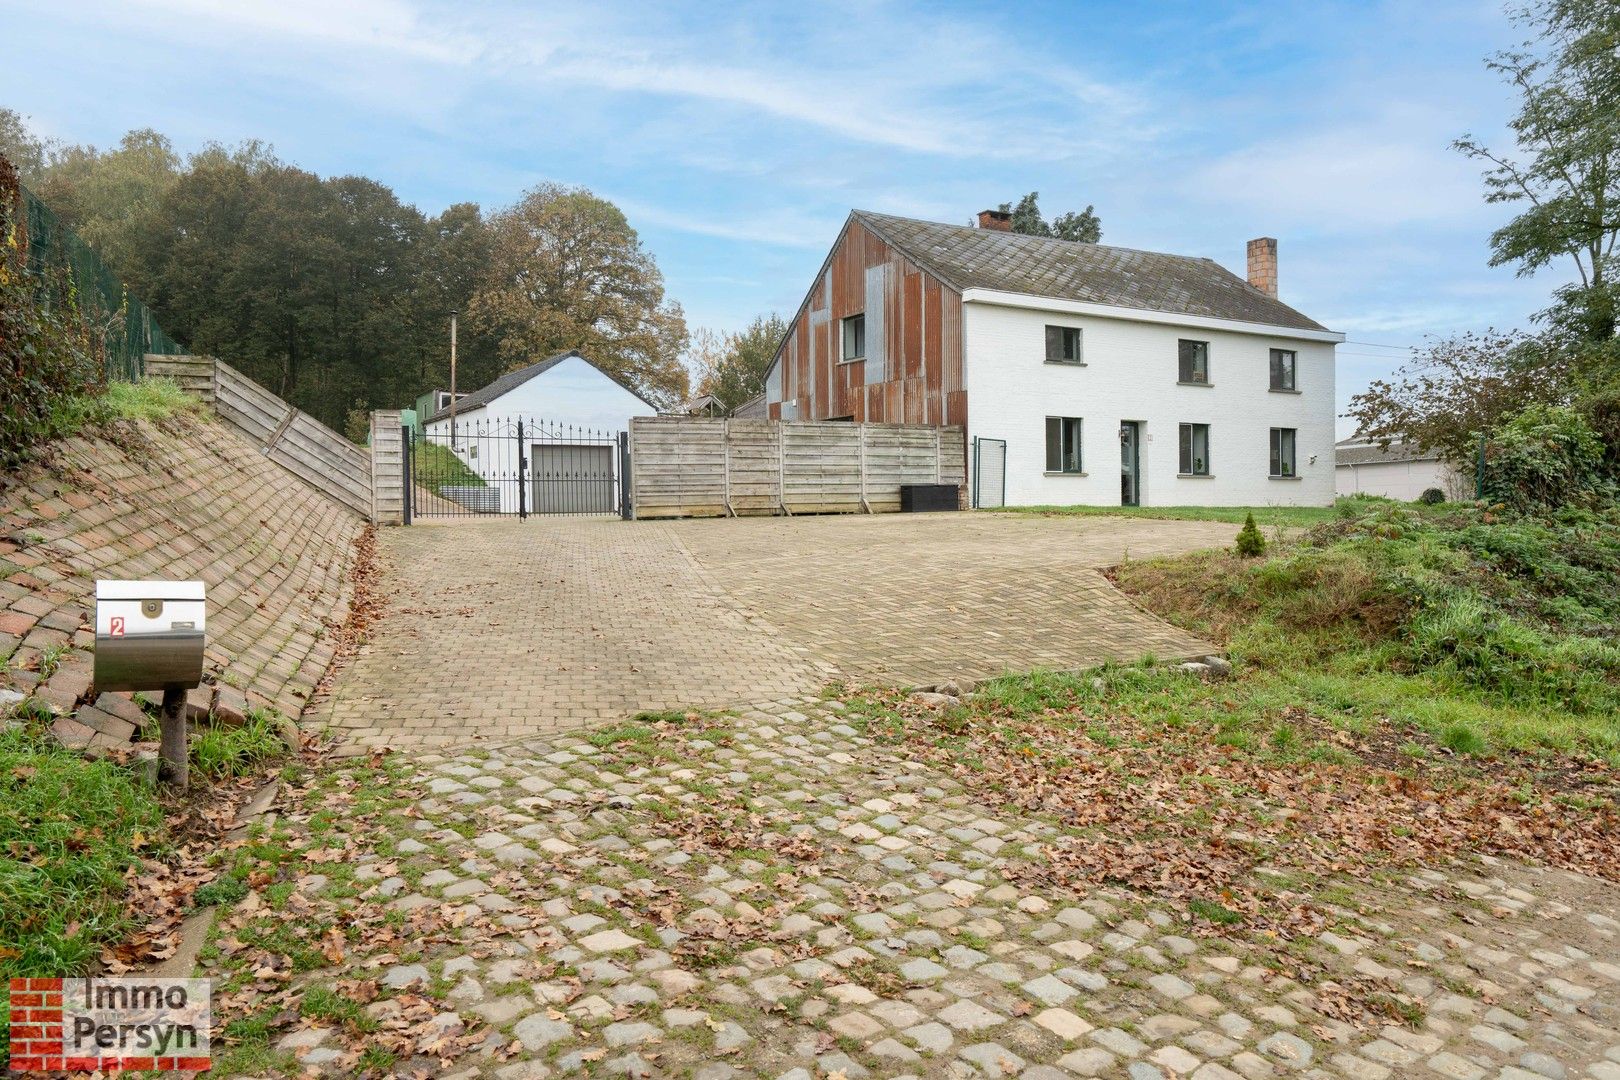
[241,699,1620,1080]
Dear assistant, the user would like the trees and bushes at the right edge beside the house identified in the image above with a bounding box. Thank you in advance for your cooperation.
[1349,0,1620,505]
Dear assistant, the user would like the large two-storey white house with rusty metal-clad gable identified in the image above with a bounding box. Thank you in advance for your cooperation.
[766,210,1345,505]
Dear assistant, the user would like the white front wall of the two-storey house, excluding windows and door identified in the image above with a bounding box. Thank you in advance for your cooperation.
[962,293,1335,507]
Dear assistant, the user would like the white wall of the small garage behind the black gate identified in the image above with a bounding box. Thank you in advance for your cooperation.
[426,356,658,513]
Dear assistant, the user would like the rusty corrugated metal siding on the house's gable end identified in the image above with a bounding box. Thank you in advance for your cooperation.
[771,219,967,424]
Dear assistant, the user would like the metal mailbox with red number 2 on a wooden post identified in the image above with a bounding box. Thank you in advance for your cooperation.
[96,581,207,691]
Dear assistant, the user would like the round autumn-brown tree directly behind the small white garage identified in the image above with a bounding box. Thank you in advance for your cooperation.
[468,183,689,405]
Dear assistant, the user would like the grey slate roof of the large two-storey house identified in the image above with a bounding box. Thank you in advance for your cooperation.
[852,210,1327,330]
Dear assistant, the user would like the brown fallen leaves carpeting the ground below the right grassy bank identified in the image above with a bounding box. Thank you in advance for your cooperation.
[876,693,1620,939]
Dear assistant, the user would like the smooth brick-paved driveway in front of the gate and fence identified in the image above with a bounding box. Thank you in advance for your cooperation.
[316,515,1233,748]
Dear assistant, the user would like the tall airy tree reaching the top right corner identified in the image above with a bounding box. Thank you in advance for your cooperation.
[1455,0,1620,342]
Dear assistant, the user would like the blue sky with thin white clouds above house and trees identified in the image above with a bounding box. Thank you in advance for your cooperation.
[0,0,1563,434]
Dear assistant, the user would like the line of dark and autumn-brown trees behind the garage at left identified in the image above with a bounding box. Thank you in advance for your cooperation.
[0,120,703,429]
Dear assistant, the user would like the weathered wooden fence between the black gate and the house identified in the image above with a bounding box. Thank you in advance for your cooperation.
[630,416,967,518]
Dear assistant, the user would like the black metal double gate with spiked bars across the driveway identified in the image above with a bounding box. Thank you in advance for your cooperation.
[403,416,630,525]
